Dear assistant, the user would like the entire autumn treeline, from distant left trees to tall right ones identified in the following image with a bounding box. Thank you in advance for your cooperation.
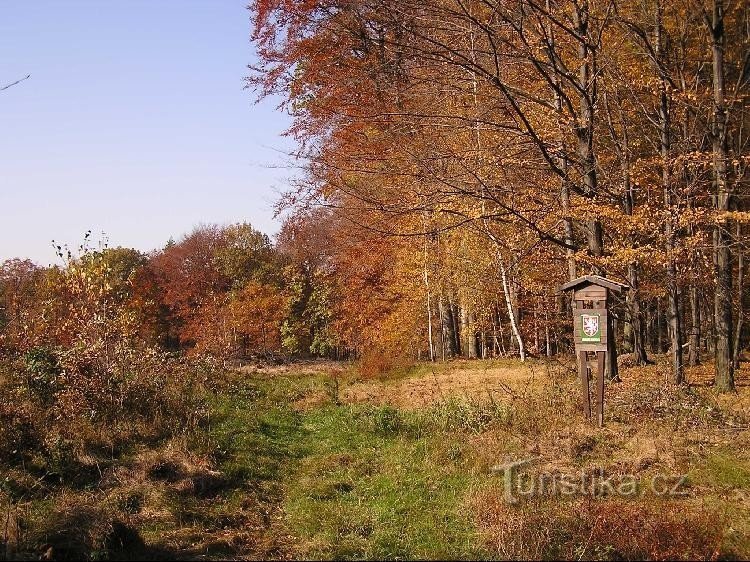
[0,0,750,390]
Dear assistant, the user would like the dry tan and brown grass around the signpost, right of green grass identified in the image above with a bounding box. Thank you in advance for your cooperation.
[332,354,750,559]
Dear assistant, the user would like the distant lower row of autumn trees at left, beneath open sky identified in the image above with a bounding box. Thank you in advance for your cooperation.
[0,224,335,360]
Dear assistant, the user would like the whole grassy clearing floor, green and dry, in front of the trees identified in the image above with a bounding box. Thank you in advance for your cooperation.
[5,359,750,559]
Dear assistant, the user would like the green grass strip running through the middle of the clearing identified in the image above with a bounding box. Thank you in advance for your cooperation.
[203,376,494,559]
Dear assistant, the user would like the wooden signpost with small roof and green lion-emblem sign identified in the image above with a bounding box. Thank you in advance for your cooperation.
[560,275,630,427]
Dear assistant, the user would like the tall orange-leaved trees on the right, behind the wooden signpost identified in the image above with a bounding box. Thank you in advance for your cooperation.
[248,0,750,390]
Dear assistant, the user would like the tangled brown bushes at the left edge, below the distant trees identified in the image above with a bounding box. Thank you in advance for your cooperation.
[0,348,220,478]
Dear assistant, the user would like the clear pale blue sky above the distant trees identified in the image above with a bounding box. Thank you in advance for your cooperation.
[0,0,295,265]
